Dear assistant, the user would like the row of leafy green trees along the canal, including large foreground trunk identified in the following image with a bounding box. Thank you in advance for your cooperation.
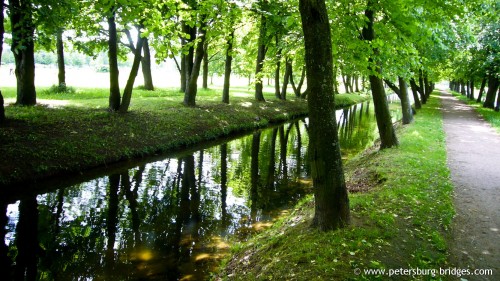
[2,0,498,229]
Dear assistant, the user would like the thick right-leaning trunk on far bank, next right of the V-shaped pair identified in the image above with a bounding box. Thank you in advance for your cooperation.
[184,17,206,107]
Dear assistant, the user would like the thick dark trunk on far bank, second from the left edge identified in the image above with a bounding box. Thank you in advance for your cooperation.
[9,0,36,105]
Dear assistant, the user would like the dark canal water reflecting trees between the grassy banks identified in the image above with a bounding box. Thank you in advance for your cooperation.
[0,100,398,280]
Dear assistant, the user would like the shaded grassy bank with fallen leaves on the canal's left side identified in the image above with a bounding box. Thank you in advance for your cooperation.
[0,87,367,187]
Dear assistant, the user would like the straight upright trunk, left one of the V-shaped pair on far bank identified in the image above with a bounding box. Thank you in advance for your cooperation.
[108,11,121,111]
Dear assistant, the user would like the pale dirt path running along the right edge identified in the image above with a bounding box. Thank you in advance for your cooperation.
[442,93,500,280]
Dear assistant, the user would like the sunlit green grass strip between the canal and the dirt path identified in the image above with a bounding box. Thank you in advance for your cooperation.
[218,95,454,280]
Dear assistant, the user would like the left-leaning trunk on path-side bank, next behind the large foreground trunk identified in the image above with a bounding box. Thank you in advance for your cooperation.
[362,4,398,149]
